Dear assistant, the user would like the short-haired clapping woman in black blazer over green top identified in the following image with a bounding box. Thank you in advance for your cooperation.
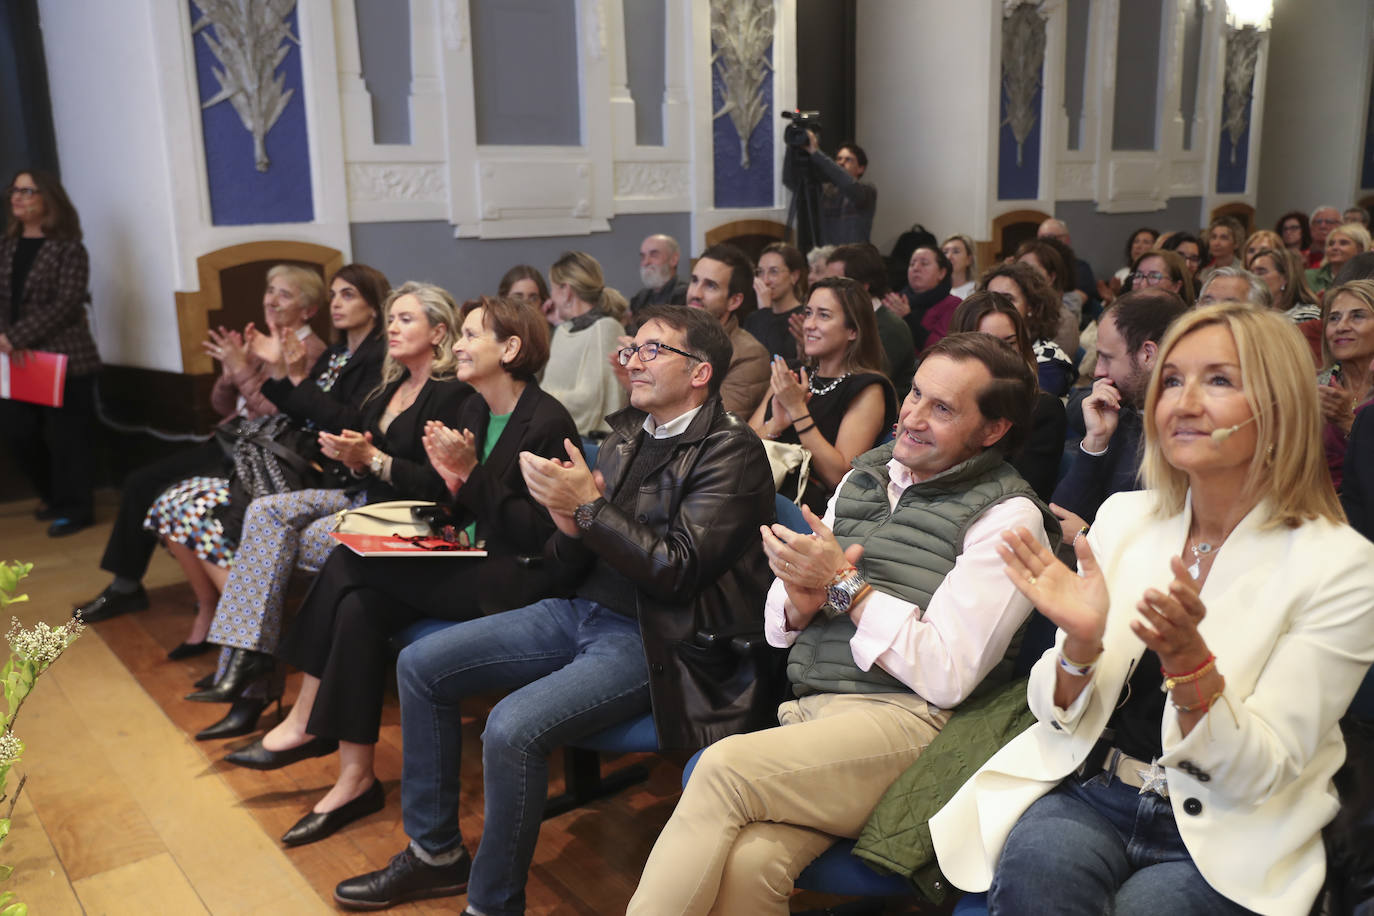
[225,298,578,846]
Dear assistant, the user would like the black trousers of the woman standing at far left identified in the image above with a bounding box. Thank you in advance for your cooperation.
[0,374,96,520]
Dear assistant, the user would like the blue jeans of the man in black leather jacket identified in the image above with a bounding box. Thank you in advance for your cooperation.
[396,599,649,916]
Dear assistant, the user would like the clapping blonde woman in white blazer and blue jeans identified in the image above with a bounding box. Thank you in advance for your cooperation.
[930,304,1374,915]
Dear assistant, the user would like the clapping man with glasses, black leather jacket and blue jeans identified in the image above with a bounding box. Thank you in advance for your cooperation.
[335,306,780,916]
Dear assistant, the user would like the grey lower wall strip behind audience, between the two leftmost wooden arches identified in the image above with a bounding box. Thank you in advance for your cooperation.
[350,213,691,302]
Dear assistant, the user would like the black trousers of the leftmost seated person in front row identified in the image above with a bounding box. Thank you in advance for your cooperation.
[100,439,228,580]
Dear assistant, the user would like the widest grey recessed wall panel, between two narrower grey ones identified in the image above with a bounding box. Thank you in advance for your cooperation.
[470,0,581,146]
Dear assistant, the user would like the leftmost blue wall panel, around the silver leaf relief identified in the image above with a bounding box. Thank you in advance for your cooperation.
[191,3,315,225]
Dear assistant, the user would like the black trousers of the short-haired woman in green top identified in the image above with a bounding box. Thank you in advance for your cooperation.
[278,547,554,744]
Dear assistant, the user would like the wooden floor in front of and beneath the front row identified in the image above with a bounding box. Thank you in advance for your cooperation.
[0,493,901,916]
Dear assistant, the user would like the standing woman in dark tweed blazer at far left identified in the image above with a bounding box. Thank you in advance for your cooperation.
[0,169,100,537]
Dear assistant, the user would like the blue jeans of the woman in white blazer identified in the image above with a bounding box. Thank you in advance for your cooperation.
[988,775,1250,916]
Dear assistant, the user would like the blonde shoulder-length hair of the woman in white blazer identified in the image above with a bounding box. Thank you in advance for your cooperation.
[1140,302,1345,529]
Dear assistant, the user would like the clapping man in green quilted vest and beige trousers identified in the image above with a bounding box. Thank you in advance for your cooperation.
[629,334,1059,913]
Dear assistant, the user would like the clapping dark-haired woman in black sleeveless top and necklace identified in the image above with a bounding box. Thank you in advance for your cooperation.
[749,277,897,514]
